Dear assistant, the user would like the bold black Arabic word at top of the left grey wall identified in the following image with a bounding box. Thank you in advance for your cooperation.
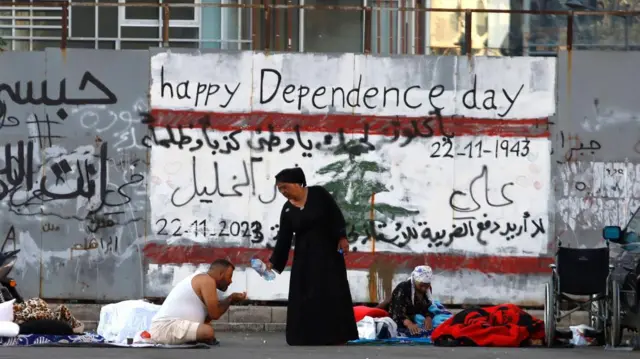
[0,71,118,106]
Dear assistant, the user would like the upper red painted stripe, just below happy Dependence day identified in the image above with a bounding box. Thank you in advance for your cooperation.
[146,110,549,138]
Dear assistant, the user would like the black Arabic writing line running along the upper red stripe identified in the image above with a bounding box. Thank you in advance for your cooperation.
[140,111,456,157]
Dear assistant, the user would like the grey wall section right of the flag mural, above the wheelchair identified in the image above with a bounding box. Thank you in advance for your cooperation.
[551,51,640,253]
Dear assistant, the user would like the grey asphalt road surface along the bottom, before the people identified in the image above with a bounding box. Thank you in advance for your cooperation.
[0,333,638,359]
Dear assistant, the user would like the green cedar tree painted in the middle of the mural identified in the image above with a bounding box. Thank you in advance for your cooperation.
[317,140,420,242]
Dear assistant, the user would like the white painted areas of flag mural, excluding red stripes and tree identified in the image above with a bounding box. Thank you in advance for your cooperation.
[147,52,555,302]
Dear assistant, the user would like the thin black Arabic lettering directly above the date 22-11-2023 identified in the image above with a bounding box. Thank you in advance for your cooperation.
[171,156,277,207]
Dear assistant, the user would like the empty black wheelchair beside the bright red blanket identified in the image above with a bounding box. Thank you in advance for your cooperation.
[544,246,622,347]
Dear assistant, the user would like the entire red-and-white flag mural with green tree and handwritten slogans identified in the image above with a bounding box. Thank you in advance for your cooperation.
[145,52,555,302]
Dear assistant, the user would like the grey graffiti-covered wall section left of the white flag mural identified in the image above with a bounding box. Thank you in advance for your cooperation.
[0,50,148,299]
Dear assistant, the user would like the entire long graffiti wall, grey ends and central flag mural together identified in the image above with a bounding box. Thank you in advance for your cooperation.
[0,50,640,304]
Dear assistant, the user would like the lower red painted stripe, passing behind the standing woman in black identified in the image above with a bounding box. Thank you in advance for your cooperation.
[143,243,553,274]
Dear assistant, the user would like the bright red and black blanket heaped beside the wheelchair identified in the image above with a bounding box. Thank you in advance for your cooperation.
[431,304,544,347]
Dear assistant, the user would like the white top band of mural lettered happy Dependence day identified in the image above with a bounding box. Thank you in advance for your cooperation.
[150,51,555,119]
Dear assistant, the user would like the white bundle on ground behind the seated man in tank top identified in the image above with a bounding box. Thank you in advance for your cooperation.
[98,300,160,344]
